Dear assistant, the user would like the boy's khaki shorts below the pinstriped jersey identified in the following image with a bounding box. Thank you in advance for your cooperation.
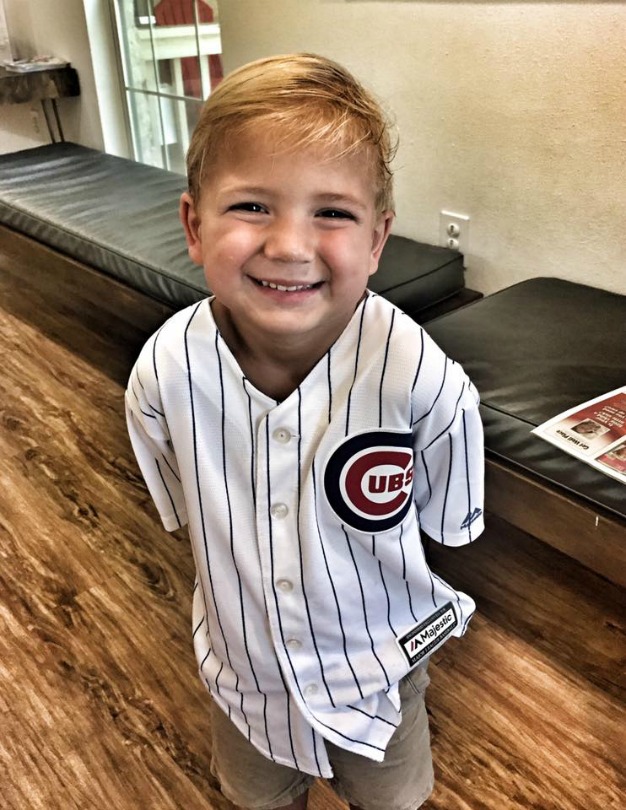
[211,665,434,810]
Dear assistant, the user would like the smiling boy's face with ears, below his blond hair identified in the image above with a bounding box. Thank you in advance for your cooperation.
[181,127,393,350]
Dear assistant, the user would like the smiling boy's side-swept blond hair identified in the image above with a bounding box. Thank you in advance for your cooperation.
[187,53,395,213]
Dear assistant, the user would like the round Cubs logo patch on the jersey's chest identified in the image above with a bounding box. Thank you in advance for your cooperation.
[324,430,413,534]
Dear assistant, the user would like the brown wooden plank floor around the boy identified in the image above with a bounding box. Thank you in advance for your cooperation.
[0,230,626,810]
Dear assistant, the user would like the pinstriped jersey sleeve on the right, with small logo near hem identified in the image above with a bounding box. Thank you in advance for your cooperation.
[413,336,484,546]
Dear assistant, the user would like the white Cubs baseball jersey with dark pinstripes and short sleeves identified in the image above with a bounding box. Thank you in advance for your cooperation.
[127,293,483,777]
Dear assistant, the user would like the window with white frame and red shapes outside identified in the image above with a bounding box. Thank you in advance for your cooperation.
[113,0,222,174]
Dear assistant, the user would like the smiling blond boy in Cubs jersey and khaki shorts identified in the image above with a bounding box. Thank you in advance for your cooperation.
[127,54,483,810]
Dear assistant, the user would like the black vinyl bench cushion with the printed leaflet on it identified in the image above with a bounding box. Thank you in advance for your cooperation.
[424,278,626,517]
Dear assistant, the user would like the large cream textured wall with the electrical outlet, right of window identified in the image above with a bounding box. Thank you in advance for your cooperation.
[220,0,626,293]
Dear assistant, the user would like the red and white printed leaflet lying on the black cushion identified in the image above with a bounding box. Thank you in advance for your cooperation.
[532,385,626,484]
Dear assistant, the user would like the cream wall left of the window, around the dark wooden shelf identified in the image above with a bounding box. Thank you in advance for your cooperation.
[0,0,103,152]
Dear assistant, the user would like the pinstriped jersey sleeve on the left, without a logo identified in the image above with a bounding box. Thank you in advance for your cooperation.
[125,341,187,531]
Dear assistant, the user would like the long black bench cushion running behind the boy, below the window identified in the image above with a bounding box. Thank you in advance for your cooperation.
[0,143,464,317]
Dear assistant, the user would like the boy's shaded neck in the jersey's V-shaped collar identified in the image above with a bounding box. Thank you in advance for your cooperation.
[212,301,343,402]
